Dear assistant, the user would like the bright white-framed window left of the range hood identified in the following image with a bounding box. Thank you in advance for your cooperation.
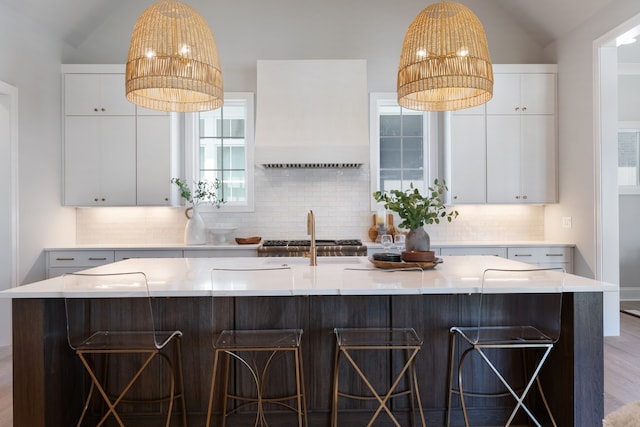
[186,93,253,211]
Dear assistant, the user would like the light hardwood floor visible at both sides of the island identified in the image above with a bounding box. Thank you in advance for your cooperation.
[0,312,640,427]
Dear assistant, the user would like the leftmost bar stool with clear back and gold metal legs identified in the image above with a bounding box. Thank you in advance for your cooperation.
[62,272,187,427]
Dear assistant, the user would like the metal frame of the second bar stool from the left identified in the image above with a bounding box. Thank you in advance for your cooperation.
[206,266,308,427]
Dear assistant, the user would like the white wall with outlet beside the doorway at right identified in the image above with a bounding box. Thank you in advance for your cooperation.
[545,0,640,277]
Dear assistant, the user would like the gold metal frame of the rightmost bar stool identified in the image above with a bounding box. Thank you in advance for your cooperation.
[446,268,564,427]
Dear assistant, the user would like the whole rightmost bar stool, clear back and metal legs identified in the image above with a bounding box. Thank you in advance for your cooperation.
[446,268,565,427]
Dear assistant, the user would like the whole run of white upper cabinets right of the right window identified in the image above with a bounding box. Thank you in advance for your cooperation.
[445,65,558,204]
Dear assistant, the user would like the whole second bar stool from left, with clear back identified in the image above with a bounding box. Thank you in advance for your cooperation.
[206,267,308,427]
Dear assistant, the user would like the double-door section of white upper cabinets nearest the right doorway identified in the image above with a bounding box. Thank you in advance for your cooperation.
[487,66,558,203]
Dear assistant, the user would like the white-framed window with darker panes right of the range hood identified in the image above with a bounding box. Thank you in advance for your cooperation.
[370,93,437,207]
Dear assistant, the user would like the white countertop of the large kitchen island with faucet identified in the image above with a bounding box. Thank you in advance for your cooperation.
[0,256,617,298]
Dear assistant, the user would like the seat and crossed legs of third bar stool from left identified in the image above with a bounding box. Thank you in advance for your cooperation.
[331,328,426,427]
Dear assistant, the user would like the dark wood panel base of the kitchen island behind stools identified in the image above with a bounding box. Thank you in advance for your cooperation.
[13,292,604,427]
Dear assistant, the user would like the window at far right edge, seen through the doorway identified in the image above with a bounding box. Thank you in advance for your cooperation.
[618,123,640,193]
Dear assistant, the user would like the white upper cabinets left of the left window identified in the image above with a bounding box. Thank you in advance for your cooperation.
[63,65,179,206]
